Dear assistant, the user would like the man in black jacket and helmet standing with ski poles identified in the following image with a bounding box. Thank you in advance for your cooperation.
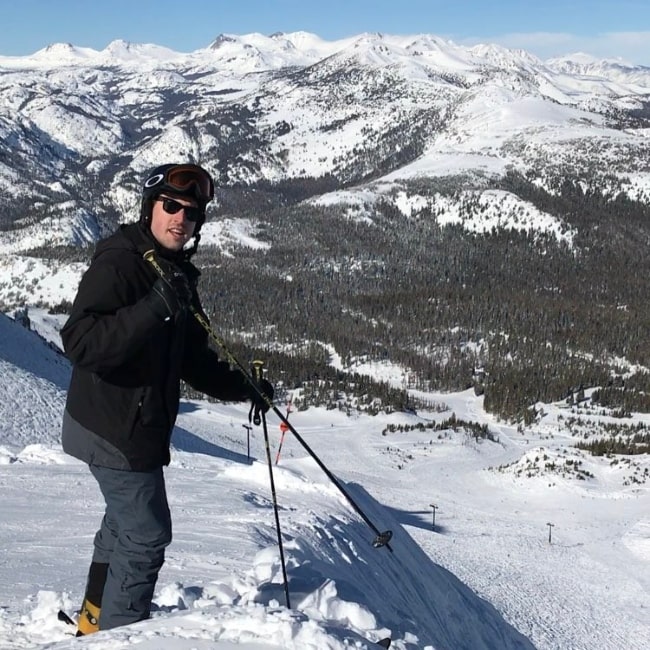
[61,164,273,636]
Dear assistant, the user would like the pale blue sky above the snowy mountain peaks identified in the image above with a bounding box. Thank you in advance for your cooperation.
[0,0,650,66]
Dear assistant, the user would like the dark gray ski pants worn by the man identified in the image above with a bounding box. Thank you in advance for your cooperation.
[90,465,172,630]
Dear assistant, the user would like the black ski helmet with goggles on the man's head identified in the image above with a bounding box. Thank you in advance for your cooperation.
[140,163,214,234]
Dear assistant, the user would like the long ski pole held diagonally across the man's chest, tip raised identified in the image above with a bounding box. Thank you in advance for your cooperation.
[143,249,393,553]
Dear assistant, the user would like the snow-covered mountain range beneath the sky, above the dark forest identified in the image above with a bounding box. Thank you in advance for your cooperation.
[0,32,650,260]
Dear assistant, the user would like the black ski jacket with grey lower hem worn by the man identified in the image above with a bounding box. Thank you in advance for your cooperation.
[61,224,250,471]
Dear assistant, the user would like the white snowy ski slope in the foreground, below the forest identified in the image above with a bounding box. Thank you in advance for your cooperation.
[0,308,650,650]
